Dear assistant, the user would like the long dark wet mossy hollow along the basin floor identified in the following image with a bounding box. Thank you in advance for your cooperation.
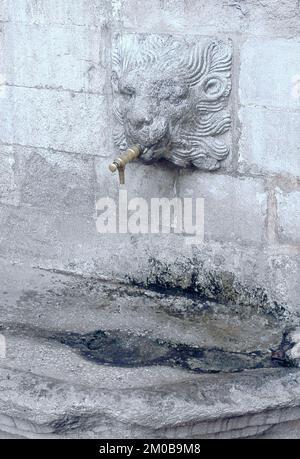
[0,324,293,373]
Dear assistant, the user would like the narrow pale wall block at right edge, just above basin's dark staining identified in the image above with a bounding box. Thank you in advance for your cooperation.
[277,191,300,244]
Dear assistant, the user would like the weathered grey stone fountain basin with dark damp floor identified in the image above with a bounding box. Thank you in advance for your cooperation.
[0,262,300,438]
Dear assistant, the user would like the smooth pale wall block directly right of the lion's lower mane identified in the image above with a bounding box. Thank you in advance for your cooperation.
[239,107,300,176]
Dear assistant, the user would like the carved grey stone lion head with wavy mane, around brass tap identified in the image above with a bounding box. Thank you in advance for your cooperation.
[112,34,232,170]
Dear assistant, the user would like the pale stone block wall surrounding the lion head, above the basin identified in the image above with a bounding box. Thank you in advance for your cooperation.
[0,0,300,311]
